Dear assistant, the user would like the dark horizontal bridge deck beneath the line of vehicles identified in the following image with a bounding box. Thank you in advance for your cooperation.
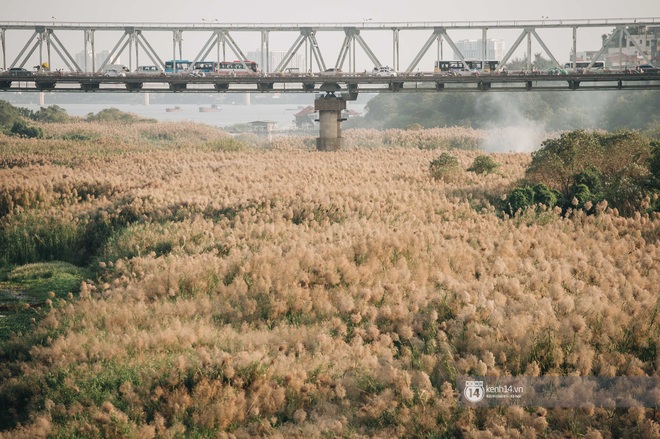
[0,72,660,94]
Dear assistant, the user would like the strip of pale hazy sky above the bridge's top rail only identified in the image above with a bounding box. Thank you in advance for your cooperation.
[0,0,660,23]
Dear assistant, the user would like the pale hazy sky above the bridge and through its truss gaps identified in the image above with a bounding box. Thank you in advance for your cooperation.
[0,0,660,68]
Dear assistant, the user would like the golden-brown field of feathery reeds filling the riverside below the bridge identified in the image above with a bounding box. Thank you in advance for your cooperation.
[0,117,660,439]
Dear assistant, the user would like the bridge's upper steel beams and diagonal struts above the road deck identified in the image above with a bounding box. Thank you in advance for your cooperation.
[0,18,660,73]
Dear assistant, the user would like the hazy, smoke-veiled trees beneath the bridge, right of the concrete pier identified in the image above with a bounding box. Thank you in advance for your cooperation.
[354,90,660,136]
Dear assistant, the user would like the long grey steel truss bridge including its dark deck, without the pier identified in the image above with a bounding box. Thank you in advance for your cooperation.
[0,18,660,99]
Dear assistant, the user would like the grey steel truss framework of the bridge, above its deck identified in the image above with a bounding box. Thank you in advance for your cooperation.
[0,18,660,74]
